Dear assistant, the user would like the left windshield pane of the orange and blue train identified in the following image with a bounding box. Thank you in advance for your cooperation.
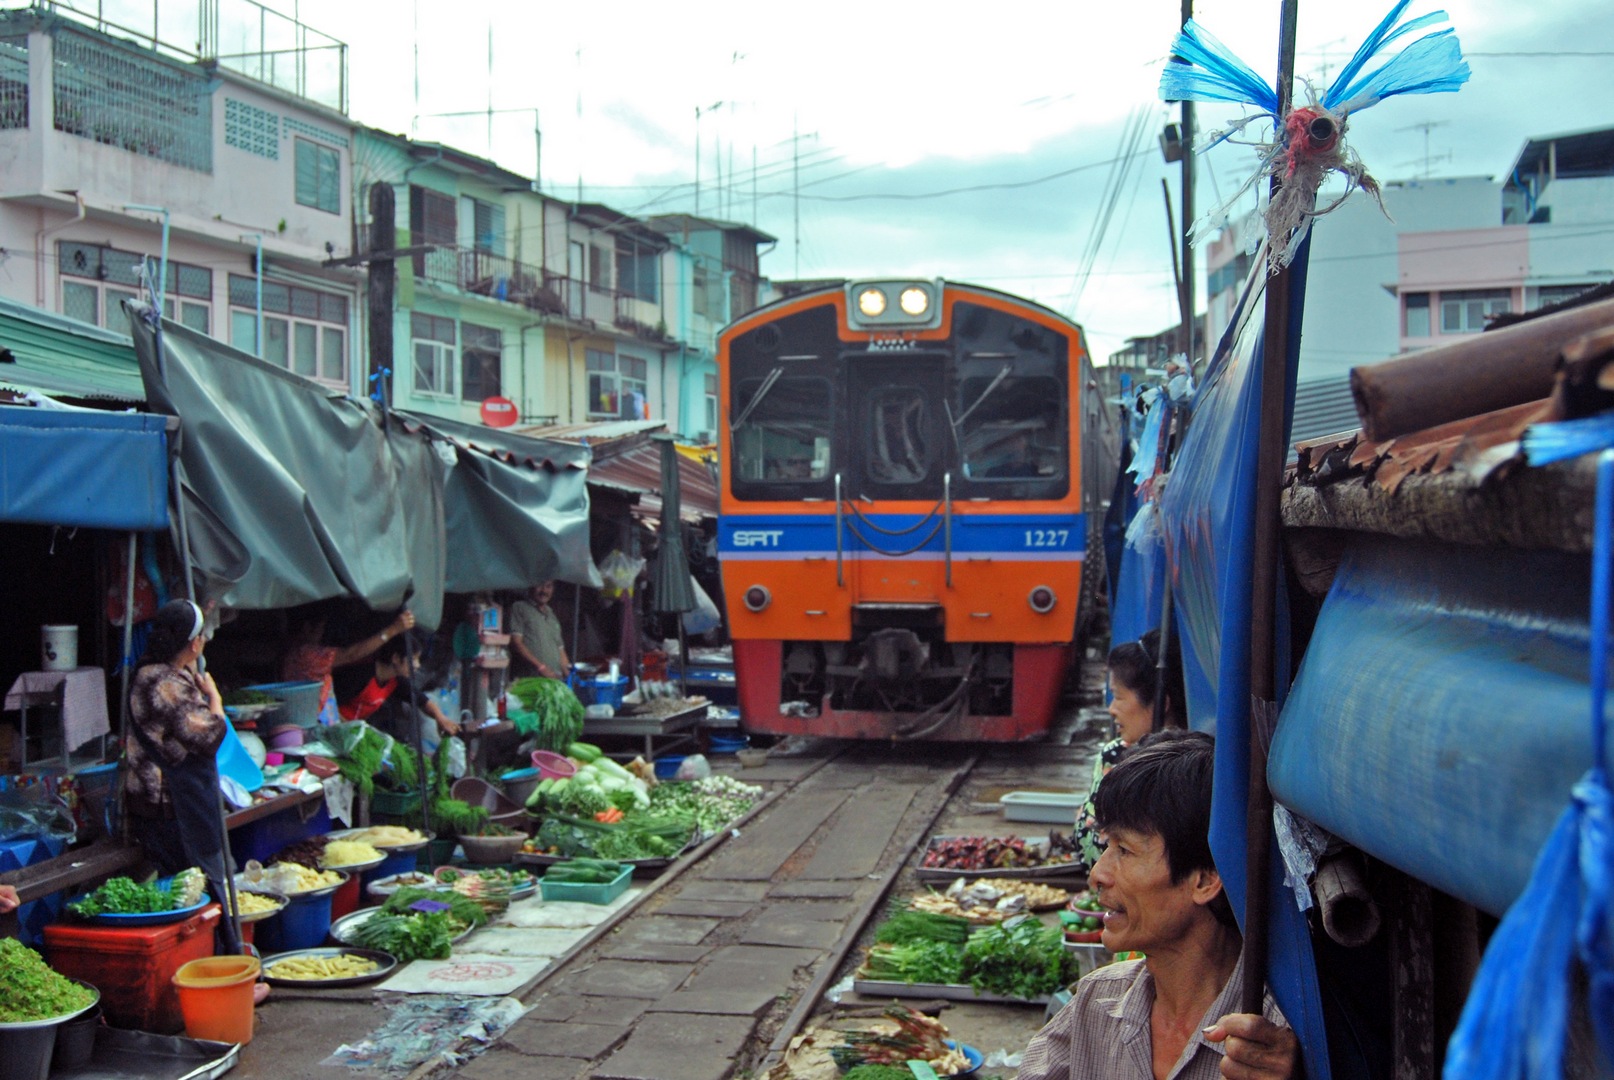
[734,376,834,484]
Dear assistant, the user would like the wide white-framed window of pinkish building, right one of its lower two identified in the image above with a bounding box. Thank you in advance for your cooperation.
[229,274,347,386]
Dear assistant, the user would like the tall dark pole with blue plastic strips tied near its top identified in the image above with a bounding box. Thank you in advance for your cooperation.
[1240,0,1299,1015]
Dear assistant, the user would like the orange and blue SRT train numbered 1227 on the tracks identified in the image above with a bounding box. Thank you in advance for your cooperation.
[717,279,1119,743]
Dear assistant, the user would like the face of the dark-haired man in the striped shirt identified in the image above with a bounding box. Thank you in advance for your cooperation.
[1088,828,1220,952]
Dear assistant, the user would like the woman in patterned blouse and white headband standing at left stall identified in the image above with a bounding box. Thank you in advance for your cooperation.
[124,601,240,954]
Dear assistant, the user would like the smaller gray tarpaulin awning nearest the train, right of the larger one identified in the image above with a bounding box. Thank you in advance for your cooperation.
[395,413,602,592]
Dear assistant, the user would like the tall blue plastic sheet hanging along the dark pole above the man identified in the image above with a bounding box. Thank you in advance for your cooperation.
[1160,237,1333,1080]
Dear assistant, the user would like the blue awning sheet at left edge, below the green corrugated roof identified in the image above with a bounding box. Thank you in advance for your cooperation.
[0,405,168,531]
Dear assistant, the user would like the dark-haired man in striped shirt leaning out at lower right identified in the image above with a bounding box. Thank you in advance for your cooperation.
[1018,731,1298,1080]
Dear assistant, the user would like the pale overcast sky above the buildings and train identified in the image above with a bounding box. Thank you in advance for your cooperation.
[278,0,1614,366]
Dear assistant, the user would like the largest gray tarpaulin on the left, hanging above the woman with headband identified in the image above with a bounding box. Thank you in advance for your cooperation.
[129,316,447,630]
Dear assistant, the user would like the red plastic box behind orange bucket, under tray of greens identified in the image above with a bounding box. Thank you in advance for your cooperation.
[45,904,220,1035]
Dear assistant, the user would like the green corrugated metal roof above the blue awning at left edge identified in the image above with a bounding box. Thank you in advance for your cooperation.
[0,299,145,402]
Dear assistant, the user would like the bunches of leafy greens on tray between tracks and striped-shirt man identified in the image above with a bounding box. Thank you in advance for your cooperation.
[857,910,1077,999]
